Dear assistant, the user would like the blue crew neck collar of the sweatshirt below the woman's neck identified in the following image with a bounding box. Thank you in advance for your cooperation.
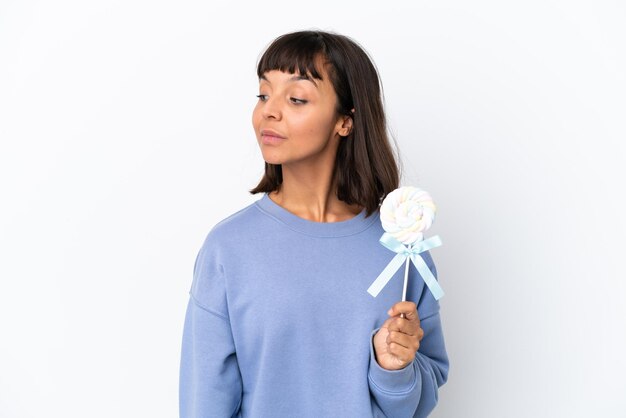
[255,193,378,238]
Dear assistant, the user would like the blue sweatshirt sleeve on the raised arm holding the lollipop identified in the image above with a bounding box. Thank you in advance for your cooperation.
[368,252,449,418]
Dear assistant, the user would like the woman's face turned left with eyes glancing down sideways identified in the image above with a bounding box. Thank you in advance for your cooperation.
[252,59,351,170]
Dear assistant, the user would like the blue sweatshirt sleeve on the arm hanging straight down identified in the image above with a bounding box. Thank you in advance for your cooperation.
[179,233,242,418]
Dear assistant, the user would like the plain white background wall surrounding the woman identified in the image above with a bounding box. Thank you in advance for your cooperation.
[0,0,626,418]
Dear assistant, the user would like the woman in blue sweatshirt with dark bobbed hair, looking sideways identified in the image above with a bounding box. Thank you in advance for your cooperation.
[180,31,448,418]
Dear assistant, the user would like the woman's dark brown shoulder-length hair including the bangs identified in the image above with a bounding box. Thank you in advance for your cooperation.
[250,30,400,216]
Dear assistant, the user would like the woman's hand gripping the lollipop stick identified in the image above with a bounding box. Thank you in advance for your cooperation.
[374,301,424,370]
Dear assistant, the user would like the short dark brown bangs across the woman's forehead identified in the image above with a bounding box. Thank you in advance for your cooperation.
[257,32,326,80]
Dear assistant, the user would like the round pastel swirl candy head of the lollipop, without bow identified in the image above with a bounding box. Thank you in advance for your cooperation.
[380,186,437,245]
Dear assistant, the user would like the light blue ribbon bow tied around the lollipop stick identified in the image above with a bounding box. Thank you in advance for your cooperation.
[367,232,443,300]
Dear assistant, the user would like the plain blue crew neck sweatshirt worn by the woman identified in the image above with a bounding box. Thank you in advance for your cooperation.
[179,194,449,418]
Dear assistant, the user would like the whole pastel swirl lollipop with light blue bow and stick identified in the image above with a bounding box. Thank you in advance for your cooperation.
[367,186,443,301]
